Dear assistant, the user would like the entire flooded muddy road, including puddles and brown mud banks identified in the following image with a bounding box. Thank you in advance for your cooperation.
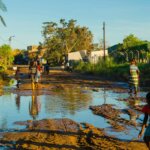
[0,68,146,149]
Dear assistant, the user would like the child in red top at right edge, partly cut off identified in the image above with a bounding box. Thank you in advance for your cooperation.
[138,92,150,150]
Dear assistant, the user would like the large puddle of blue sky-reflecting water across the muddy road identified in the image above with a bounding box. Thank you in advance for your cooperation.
[0,86,146,140]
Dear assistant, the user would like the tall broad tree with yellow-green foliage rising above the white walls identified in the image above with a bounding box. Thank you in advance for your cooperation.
[42,19,93,64]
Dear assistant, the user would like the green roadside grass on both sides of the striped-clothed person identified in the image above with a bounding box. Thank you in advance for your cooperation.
[74,58,150,82]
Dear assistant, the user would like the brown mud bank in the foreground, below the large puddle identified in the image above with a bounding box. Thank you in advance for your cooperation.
[0,119,146,150]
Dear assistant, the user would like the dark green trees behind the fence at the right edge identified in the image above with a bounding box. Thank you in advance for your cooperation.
[108,34,150,62]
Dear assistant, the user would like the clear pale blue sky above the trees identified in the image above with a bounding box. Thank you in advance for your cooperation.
[0,0,150,49]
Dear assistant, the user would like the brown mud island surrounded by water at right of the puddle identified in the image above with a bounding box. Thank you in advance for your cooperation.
[90,104,140,132]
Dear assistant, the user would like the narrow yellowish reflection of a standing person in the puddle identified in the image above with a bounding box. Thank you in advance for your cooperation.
[29,91,41,120]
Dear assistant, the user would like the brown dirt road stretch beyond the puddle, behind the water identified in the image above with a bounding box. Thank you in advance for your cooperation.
[11,67,125,94]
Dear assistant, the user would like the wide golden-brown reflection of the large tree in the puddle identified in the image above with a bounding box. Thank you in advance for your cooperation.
[45,85,92,116]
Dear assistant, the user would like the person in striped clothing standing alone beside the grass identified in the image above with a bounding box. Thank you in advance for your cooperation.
[129,59,139,95]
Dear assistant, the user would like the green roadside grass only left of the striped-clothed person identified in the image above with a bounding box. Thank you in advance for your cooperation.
[74,57,129,79]
